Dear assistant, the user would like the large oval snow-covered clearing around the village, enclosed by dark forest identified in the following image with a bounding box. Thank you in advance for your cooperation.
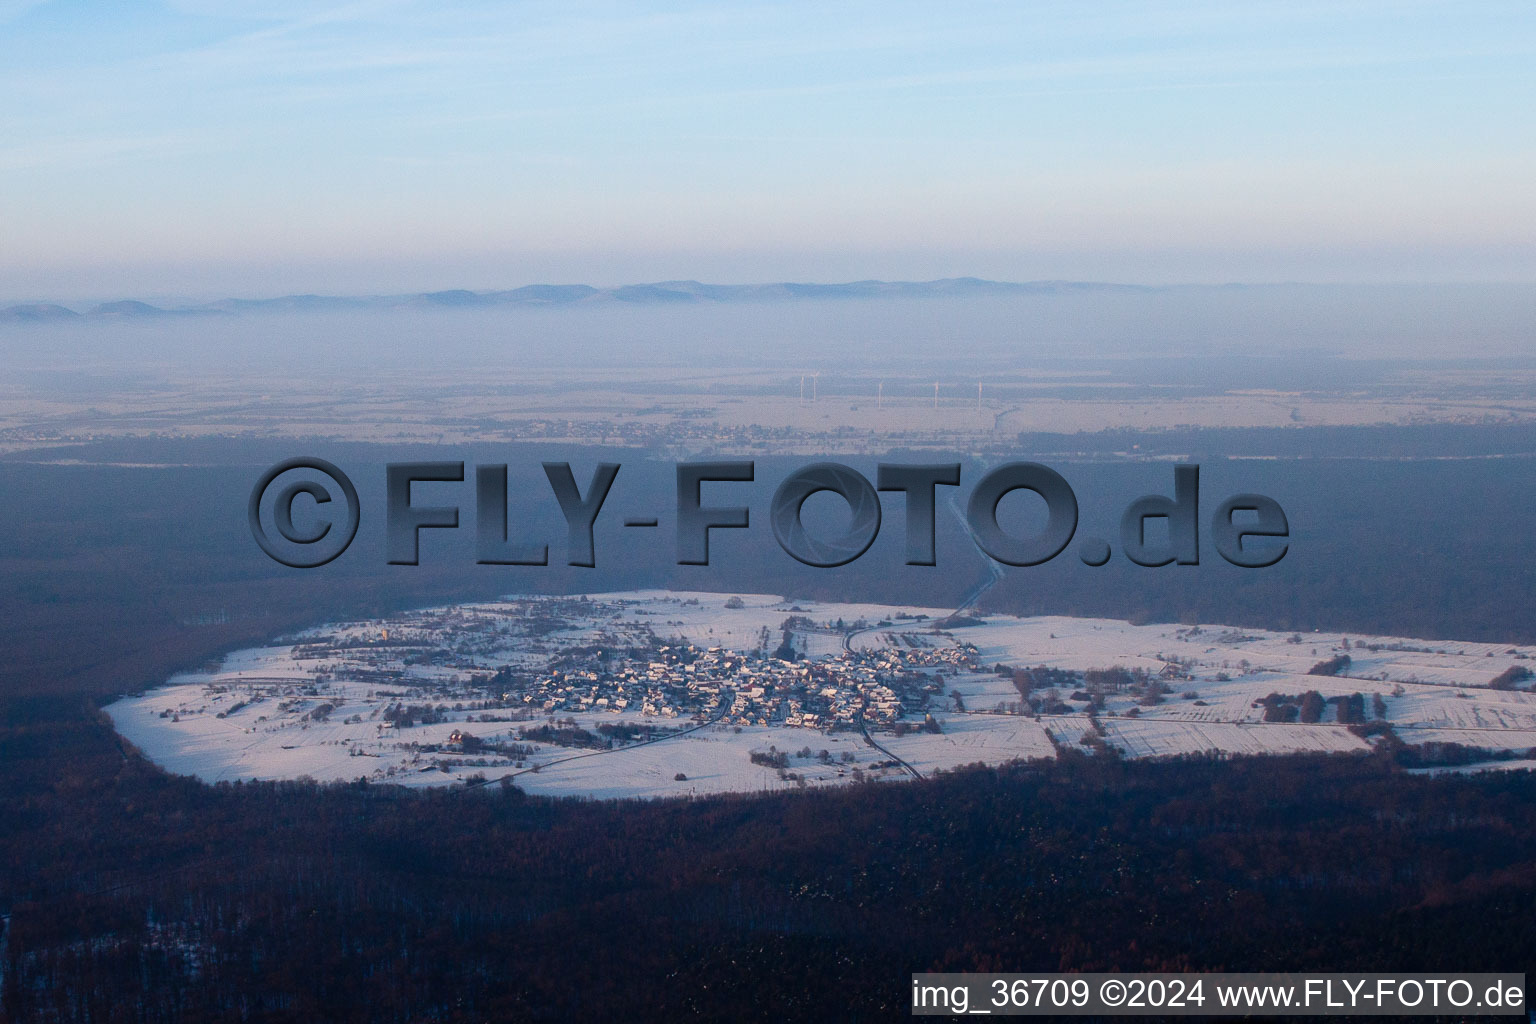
[108,591,1536,798]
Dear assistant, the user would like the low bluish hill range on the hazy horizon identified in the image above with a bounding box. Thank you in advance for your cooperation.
[0,278,1152,324]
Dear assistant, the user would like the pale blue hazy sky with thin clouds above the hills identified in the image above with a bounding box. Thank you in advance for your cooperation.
[0,0,1536,301]
